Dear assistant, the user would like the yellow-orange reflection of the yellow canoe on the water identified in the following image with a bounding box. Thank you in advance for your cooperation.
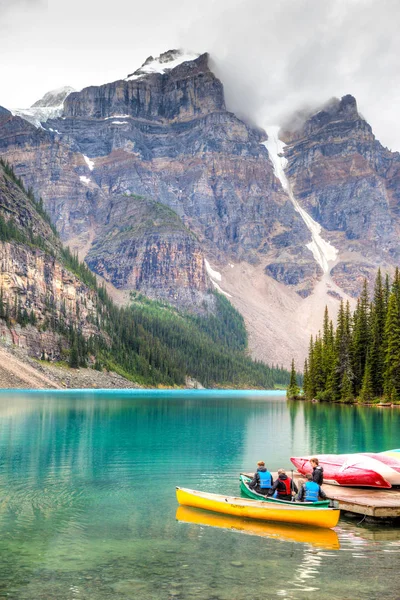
[176,506,340,550]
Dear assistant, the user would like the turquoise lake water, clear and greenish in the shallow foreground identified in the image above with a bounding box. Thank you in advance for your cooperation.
[0,391,400,600]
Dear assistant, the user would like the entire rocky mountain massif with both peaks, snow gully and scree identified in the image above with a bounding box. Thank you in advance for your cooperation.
[0,51,400,365]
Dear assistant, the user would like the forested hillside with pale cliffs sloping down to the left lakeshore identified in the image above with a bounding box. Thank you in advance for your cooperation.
[0,157,289,388]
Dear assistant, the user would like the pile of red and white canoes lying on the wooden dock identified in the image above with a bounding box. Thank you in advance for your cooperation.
[290,453,400,488]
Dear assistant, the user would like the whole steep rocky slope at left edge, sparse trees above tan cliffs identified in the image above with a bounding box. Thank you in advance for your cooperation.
[0,159,98,359]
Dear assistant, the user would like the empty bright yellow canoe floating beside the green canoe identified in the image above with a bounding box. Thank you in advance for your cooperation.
[176,487,340,529]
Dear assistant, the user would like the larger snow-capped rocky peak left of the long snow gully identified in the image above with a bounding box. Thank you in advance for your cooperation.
[0,54,313,306]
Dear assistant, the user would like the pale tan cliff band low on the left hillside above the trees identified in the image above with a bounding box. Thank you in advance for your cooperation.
[0,242,98,360]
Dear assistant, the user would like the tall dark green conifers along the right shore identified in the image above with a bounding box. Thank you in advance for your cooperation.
[288,269,400,403]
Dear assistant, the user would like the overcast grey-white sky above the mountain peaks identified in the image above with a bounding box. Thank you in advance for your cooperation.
[0,0,400,150]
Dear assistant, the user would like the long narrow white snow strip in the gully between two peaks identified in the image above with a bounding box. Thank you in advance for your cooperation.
[263,126,339,273]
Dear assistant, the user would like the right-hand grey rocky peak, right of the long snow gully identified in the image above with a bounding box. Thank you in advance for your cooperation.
[284,96,400,294]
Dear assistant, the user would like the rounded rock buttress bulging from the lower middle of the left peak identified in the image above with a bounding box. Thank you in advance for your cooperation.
[86,195,214,310]
